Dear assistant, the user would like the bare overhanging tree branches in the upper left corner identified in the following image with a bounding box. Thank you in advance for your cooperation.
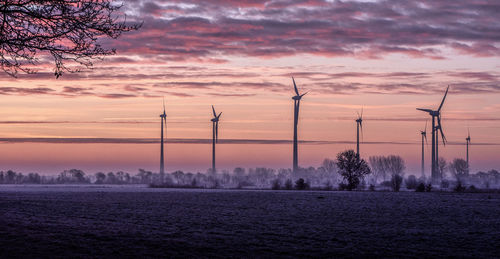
[0,0,141,78]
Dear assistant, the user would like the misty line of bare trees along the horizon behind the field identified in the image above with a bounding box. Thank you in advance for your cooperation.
[0,150,500,191]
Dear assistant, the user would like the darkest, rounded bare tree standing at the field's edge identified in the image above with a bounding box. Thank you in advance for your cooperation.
[336,150,371,190]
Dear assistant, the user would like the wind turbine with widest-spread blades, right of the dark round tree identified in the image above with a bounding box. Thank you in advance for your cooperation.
[417,86,450,181]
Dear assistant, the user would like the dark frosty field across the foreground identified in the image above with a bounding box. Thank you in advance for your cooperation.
[0,187,500,258]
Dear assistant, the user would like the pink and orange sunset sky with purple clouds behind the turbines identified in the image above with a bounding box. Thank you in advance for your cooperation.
[0,0,500,175]
